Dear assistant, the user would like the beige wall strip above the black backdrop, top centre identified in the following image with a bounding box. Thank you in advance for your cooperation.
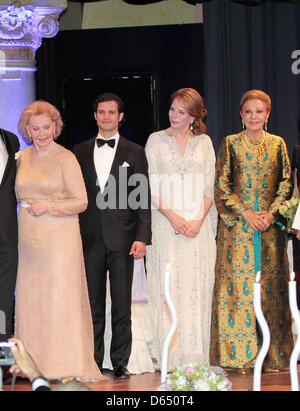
[82,0,196,29]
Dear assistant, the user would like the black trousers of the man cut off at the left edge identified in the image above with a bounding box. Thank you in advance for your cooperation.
[0,244,18,341]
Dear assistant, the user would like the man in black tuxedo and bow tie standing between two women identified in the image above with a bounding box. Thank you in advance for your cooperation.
[74,93,151,378]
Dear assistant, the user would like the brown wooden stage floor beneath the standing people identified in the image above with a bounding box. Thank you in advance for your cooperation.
[3,365,300,392]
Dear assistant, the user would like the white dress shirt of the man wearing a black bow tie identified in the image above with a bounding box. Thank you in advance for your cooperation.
[94,133,120,193]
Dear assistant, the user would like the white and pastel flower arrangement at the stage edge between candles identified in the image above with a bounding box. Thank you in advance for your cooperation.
[157,363,232,391]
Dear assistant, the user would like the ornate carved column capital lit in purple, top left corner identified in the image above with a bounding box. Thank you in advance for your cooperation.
[0,0,67,77]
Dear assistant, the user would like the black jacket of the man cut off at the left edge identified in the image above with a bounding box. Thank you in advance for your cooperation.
[0,129,20,244]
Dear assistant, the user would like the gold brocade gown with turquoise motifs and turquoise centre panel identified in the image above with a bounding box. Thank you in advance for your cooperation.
[210,133,293,368]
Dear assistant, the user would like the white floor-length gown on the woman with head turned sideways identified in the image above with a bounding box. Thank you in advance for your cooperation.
[146,131,217,370]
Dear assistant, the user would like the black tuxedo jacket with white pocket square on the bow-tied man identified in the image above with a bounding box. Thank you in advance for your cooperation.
[74,136,151,252]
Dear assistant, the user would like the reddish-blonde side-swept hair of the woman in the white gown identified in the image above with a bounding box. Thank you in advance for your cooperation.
[171,88,207,135]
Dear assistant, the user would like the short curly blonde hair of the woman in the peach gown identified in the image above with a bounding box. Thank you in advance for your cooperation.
[18,100,63,142]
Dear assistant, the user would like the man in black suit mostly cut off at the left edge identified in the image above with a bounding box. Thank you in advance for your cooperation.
[0,129,19,341]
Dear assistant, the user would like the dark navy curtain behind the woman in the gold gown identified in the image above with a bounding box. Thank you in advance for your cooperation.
[203,0,300,154]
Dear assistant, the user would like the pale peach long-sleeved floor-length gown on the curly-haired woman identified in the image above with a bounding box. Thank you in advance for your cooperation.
[15,143,104,381]
